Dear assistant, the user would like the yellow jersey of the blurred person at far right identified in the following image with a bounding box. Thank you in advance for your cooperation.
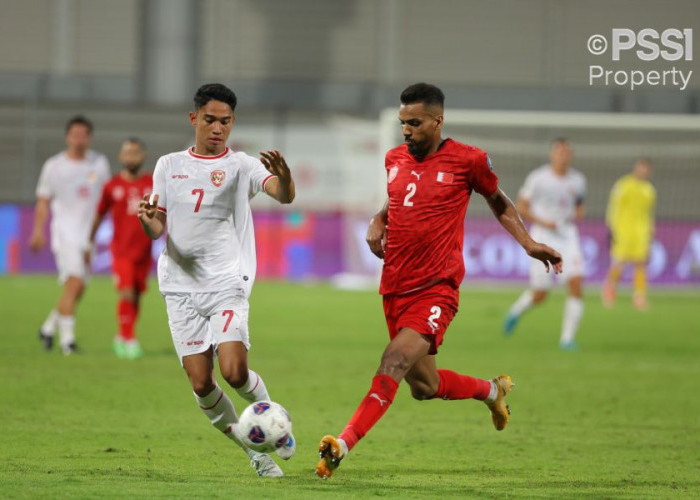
[605,174,656,238]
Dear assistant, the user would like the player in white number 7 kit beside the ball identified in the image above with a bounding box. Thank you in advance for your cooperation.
[138,83,295,477]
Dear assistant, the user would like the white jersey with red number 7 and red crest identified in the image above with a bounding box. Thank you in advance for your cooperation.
[153,148,273,297]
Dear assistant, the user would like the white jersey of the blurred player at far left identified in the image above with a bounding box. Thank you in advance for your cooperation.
[36,150,110,252]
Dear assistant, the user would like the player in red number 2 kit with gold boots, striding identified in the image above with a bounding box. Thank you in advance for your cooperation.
[316,83,562,479]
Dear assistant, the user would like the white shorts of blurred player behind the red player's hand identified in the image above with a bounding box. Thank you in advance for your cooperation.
[530,230,585,290]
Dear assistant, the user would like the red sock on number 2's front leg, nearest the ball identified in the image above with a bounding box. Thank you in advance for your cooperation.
[338,375,399,450]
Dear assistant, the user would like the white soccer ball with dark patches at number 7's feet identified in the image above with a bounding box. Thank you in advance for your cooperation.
[236,401,292,453]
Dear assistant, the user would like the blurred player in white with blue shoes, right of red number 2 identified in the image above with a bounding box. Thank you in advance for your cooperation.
[504,138,586,350]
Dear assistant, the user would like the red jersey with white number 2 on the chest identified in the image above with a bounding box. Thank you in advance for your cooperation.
[379,139,498,295]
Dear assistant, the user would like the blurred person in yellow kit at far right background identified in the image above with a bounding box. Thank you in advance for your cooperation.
[602,158,656,310]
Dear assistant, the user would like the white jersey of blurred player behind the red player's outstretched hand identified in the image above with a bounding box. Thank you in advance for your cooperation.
[518,165,586,243]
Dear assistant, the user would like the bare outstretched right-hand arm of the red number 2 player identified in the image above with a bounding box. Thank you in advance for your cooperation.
[486,188,562,273]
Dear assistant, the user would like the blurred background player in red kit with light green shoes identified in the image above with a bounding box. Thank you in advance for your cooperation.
[87,138,153,359]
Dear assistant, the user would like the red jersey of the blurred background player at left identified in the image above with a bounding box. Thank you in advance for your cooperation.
[97,174,153,262]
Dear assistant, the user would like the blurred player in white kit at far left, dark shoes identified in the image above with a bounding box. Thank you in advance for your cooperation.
[29,116,110,355]
